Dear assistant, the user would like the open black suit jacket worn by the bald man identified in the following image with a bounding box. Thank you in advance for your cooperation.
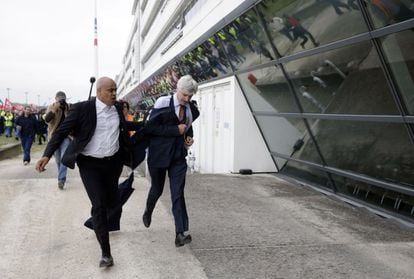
[43,98,143,169]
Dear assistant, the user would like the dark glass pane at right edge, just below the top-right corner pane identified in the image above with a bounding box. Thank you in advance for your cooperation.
[381,30,414,114]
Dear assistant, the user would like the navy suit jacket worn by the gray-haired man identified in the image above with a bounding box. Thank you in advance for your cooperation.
[146,97,200,168]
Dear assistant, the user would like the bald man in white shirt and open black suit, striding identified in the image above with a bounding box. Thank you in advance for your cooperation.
[36,77,146,267]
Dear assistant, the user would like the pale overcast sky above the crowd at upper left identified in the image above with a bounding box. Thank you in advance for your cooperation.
[0,0,134,105]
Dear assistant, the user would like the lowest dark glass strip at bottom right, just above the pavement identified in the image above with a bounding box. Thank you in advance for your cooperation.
[331,174,414,221]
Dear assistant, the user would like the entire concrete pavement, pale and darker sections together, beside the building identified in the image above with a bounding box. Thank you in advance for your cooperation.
[0,152,414,279]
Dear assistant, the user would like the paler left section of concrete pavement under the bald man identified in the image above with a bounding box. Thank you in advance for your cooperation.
[0,155,207,279]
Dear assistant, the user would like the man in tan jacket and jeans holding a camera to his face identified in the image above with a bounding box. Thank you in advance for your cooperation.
[44,91,71,190]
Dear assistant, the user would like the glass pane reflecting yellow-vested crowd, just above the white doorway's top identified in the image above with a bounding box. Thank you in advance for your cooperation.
[217,10,275,69]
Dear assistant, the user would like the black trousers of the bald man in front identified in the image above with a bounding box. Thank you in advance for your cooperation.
[77,154,122,256]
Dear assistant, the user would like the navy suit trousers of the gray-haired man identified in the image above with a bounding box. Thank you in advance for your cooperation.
[147,160,188,233]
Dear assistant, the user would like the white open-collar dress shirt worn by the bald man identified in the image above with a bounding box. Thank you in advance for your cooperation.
[81,98,120,158]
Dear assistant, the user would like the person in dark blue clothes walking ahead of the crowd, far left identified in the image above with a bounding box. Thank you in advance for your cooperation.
[16,106,38,166]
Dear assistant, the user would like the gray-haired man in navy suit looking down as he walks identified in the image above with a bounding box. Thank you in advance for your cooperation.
[142,75,200,247]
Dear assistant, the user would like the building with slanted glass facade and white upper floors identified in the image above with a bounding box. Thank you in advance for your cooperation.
[117,0,414,222]
